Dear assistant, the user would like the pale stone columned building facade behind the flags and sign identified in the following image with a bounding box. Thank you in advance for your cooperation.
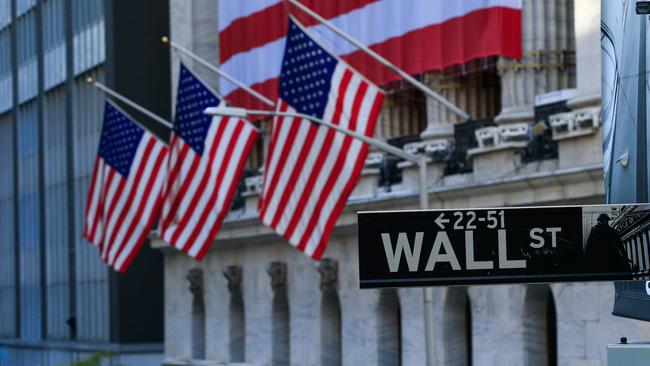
[153,0,650,366]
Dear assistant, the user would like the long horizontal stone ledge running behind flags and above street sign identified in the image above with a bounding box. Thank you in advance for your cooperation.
[151,164,604,253]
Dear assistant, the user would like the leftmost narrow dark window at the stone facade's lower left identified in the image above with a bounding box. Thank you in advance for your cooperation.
[187,268,205,360]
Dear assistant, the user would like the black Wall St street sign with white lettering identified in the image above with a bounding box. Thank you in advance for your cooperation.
[358,205,650,288]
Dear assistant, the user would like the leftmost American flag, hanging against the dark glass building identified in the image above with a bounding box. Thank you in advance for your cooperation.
[83,102,168,272]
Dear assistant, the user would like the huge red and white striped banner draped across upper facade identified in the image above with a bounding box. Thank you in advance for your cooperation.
[219,0,522,108]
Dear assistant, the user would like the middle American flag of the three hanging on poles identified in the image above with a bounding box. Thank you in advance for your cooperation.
[160,65,258,260]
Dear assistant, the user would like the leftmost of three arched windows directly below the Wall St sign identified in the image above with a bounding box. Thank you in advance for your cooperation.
[377,289,402,366]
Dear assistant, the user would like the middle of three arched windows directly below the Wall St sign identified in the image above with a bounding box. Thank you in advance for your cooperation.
[444,287,472,366]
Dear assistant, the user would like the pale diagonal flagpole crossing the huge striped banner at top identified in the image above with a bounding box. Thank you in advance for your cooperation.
[287,0,470,121]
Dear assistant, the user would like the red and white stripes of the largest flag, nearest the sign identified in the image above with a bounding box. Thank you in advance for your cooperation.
[259,63,383,259]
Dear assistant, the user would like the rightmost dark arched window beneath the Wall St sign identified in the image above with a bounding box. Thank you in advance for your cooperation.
[524,285,557,366]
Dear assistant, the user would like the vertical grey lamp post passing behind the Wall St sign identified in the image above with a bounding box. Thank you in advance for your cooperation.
[418,156,436,366]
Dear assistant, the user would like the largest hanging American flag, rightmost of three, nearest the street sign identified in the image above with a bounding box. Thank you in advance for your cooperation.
[259,16,384,259]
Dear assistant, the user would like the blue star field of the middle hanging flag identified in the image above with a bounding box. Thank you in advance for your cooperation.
[174,64,221,155]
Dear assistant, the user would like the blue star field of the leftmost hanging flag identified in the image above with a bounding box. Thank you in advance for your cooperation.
[99,102,144,178]
